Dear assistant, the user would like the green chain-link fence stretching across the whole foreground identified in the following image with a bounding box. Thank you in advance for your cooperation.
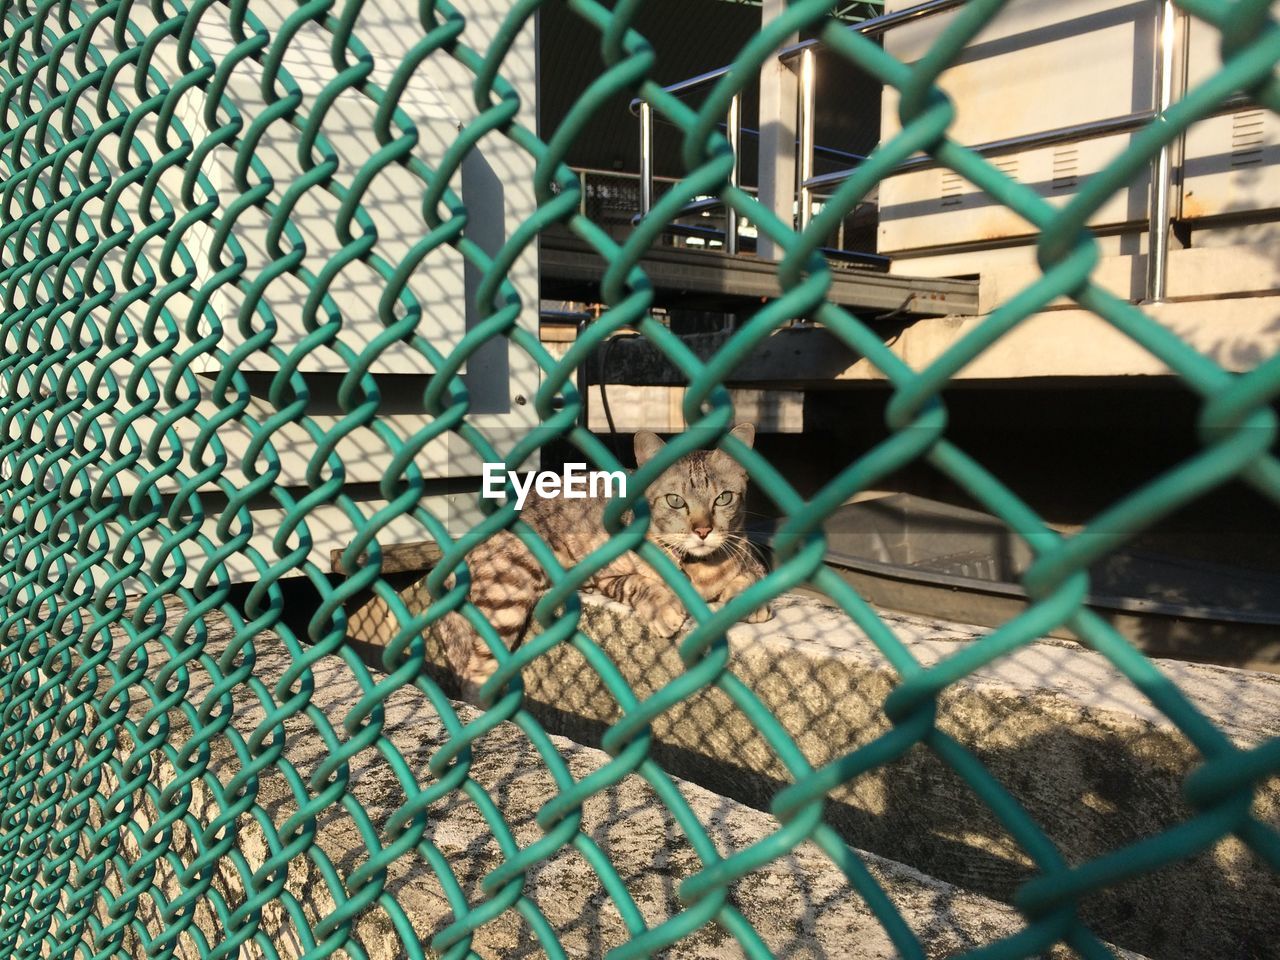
[0,0,1280,957]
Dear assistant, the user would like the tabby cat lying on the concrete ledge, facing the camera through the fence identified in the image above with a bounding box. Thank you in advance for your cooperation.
[436,424,773,700]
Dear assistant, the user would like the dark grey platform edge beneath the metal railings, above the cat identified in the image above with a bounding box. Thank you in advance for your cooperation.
[539,230,978,317]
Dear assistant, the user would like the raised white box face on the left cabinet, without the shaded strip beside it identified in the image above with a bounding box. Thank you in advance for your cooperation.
[177,3,491,372]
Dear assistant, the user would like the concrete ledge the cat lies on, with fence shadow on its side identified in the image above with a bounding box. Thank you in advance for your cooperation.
[496,598,1280,959]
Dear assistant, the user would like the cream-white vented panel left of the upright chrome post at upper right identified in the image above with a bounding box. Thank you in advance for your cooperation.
[879,0,1155,255]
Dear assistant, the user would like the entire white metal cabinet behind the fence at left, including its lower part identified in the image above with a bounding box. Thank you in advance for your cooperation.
[68,0,540,586]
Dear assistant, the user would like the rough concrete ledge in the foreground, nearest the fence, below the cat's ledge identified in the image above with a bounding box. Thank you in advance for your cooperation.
[92,601,1152,960]
